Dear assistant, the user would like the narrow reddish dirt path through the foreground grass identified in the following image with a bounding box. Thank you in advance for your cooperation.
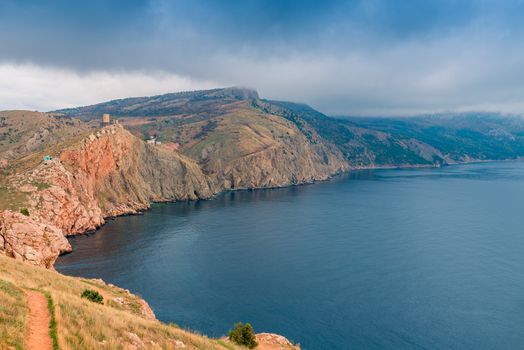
[25,290,53,350]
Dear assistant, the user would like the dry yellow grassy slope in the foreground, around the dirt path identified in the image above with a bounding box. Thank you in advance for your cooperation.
[0,256,241,350]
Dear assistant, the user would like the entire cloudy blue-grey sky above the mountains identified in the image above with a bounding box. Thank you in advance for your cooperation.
[0,0,524,116]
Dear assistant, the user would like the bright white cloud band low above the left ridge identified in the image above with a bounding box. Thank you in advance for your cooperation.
[0,64,217,111]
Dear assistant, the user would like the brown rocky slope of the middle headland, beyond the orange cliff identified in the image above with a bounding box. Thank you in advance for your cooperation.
[174,101,348,190]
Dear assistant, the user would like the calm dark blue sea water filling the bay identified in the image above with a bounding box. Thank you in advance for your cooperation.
[56,163,524,349]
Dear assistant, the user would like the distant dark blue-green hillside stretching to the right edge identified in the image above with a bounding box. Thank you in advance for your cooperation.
[270,101,524,167]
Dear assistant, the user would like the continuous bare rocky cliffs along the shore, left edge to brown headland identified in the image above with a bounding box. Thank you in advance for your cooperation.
[0,110,347,267]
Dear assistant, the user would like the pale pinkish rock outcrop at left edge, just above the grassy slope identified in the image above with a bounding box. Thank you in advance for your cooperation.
[0,210,71,268]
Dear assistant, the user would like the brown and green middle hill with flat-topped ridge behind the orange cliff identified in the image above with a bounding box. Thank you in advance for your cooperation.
[53,88,348,190]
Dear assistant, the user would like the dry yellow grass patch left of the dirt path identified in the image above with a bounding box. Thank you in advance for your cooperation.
[0,279,28,349]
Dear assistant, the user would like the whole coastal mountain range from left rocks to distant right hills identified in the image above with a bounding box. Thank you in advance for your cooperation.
[0,87,524,267]
